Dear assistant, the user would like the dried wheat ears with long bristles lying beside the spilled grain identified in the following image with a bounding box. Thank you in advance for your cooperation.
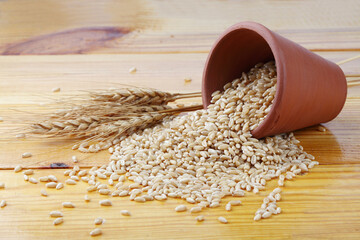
[30,88,203,152]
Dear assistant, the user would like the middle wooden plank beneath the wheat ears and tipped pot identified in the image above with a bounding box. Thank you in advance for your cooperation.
[0,52,360,169]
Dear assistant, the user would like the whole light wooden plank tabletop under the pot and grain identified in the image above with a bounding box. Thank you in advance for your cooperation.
[0,0,360,239]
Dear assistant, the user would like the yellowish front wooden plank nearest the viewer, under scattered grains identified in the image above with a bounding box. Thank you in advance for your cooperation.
[0,164,360,239]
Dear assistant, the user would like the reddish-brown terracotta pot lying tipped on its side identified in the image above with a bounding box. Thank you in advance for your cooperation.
[202,22,347,138]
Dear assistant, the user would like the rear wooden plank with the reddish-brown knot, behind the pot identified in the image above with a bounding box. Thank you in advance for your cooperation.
[0,0,360,55]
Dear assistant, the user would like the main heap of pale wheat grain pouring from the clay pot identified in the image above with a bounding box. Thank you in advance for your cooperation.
[70,62,317,220]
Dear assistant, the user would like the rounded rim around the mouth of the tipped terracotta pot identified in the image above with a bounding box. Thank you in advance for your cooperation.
[202,22,286,138]
